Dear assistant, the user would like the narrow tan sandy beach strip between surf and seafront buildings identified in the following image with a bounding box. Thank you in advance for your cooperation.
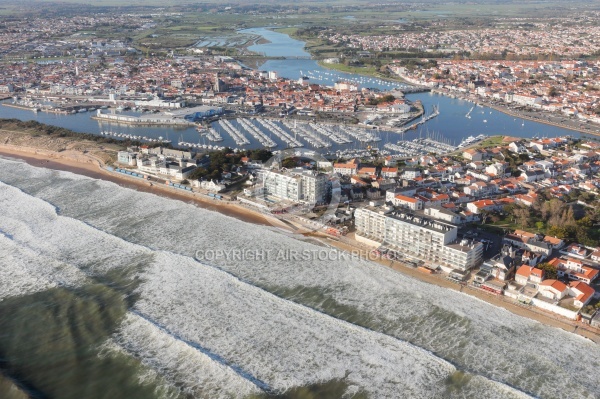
[0,144,600,343]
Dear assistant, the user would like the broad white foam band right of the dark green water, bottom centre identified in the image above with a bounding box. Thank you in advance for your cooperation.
[136,252,455,398]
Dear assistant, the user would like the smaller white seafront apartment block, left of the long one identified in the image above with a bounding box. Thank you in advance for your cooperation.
[258,169,328,203]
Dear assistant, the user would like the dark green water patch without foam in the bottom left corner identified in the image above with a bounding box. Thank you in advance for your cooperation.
[0,270,178,399]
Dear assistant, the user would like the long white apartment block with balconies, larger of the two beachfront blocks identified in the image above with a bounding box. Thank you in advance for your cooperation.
[354,208,483,271]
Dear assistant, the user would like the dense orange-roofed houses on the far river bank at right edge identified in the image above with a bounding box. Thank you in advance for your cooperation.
[390,60,600,123]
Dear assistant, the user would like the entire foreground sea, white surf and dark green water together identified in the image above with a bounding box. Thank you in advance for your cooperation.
[0,159,600,399]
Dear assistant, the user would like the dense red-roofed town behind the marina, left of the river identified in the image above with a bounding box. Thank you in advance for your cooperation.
[0,56,404,112]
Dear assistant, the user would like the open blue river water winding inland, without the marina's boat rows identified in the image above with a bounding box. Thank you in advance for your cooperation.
[0,28,596,150]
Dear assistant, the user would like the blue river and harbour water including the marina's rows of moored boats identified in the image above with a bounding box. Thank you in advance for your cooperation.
[0,28,586,153]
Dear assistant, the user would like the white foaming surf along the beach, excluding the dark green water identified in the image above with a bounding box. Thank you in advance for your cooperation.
[0,159,600,398]
